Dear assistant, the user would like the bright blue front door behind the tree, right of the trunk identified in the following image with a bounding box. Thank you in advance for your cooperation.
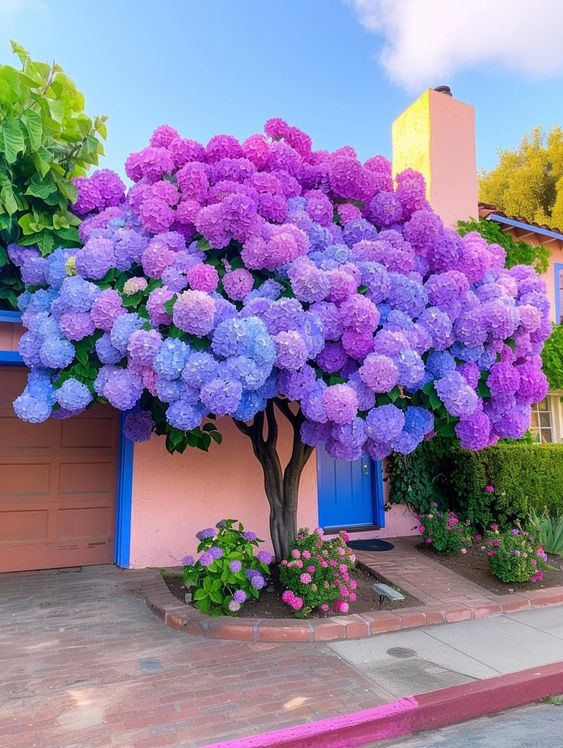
[317,447,385,528]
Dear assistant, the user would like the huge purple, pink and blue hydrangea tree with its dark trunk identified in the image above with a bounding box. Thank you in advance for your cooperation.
[11,119,551,560]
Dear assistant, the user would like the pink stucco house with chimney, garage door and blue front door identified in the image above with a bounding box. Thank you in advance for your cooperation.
[0,90,504,571]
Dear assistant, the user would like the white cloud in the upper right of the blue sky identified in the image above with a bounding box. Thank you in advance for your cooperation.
[346,0,563,91]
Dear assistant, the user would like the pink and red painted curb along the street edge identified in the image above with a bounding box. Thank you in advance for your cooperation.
[204,662,563,748]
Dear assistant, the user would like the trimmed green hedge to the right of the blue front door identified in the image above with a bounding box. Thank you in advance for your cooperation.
[389,440,563,529]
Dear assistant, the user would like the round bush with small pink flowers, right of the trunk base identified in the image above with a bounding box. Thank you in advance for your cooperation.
[279,527,357,618]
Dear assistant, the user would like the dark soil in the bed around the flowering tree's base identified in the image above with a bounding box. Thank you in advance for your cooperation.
[163,566,420,618]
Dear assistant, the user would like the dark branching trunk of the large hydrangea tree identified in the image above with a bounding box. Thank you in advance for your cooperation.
[235,398,313,563]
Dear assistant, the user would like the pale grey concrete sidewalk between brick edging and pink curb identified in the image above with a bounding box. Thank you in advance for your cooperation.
[328,607,563,700]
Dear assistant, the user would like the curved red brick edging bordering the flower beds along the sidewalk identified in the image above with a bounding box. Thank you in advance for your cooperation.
[141,570,563,642]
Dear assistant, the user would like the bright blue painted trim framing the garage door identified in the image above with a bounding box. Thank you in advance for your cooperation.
[0,350,134,569]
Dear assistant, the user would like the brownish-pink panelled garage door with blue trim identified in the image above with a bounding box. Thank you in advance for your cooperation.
[0,366,119,572]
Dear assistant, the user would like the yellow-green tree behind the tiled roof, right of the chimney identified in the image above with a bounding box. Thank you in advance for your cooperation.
[479,127,563,226]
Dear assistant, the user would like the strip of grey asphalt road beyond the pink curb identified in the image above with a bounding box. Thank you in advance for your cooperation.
[373,703,563,748]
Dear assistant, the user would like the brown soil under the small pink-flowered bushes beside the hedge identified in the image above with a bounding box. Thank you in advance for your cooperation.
[416,543,563,595]
